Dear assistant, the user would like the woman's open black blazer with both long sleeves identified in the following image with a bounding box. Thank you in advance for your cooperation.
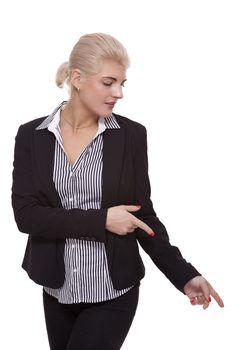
[12,114,200,292]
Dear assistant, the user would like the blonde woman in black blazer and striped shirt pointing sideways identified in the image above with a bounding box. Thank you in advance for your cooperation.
[12,33,223,350]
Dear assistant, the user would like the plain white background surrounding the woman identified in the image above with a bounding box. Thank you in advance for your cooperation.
[0,0,233,350]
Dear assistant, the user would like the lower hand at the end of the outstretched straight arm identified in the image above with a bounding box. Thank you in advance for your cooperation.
[184,276,224,310]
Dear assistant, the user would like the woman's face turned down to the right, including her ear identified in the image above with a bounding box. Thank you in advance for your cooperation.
[71,61,126,117]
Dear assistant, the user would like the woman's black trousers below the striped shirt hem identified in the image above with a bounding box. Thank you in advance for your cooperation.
[43,285,139,350]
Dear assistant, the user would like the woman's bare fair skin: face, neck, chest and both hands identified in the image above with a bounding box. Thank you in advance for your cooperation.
[60,61,224,309]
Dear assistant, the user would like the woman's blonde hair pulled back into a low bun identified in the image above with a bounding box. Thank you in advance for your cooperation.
[56,33,130,88]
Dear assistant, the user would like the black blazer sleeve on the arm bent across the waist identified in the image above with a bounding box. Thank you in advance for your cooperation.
[11,125,107,242]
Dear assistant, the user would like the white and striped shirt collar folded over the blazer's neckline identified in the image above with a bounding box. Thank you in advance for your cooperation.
[36,101,120,134]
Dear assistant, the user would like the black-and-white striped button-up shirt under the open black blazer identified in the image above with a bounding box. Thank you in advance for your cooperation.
[37,101,133,304]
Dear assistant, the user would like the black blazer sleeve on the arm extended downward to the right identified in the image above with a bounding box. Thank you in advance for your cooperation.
[132,125,200,293]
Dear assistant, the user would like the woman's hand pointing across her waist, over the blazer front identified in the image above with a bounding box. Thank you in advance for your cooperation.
[106,205,154,236]
